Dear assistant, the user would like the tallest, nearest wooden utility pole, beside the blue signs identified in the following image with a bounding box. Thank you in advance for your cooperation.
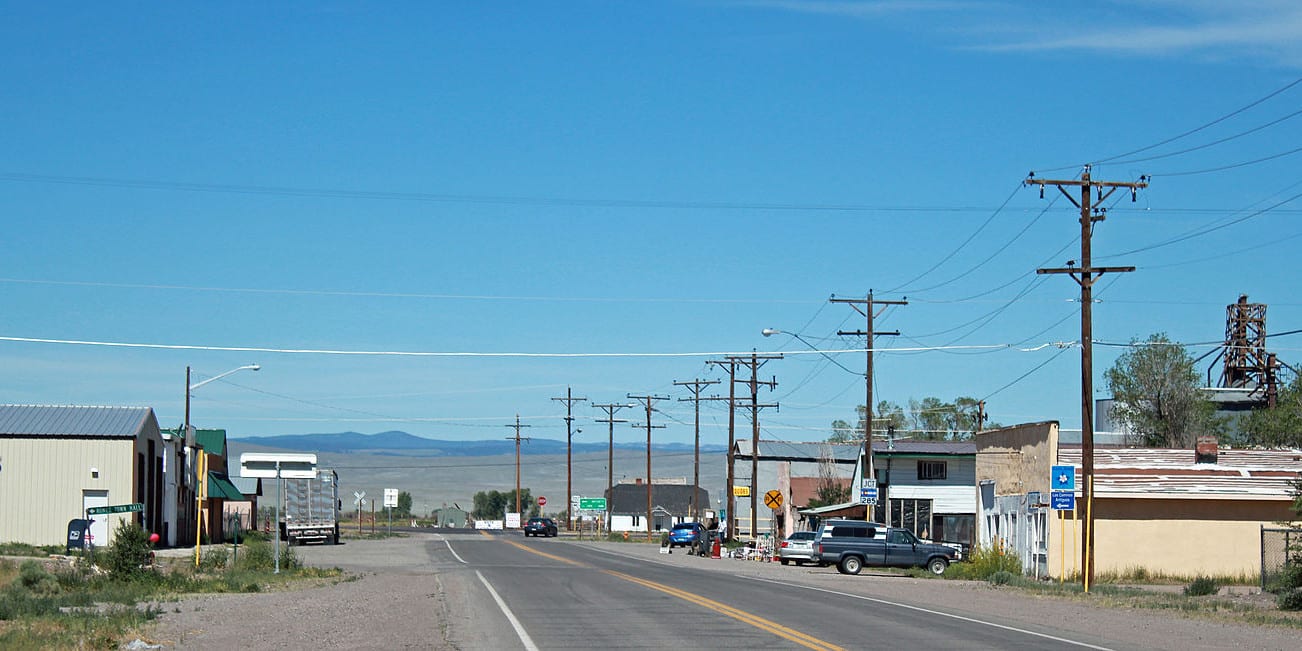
[1025,165,1148,592]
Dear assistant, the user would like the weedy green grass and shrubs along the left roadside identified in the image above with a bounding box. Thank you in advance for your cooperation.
[0,540,357,648]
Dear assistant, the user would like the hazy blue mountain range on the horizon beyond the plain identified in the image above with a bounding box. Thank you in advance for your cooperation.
[230,431,728,457]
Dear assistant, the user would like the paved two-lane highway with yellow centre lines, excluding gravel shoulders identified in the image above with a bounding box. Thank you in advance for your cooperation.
[431,534,1131,650]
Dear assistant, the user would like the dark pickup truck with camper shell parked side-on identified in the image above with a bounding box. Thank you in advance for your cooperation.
[812,519,958,574]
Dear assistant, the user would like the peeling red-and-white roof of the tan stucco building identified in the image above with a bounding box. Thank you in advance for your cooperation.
[1059,447,1302,500]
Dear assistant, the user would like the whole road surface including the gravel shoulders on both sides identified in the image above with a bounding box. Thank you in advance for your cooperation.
[149,533,1297,650]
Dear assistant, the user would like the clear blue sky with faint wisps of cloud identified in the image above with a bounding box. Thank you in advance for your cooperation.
[0,0,1302,443]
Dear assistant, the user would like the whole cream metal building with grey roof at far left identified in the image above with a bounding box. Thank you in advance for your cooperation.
[0,405,164,546]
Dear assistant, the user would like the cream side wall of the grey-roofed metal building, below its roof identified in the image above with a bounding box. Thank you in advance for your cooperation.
[0,437,135,544]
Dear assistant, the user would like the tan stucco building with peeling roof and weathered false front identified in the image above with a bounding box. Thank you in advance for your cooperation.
[975,422,1302,577]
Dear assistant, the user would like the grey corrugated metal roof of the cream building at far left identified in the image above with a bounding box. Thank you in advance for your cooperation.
[0,405,154,439]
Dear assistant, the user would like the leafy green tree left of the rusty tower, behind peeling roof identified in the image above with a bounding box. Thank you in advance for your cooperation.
[1107,332,1217,448]
